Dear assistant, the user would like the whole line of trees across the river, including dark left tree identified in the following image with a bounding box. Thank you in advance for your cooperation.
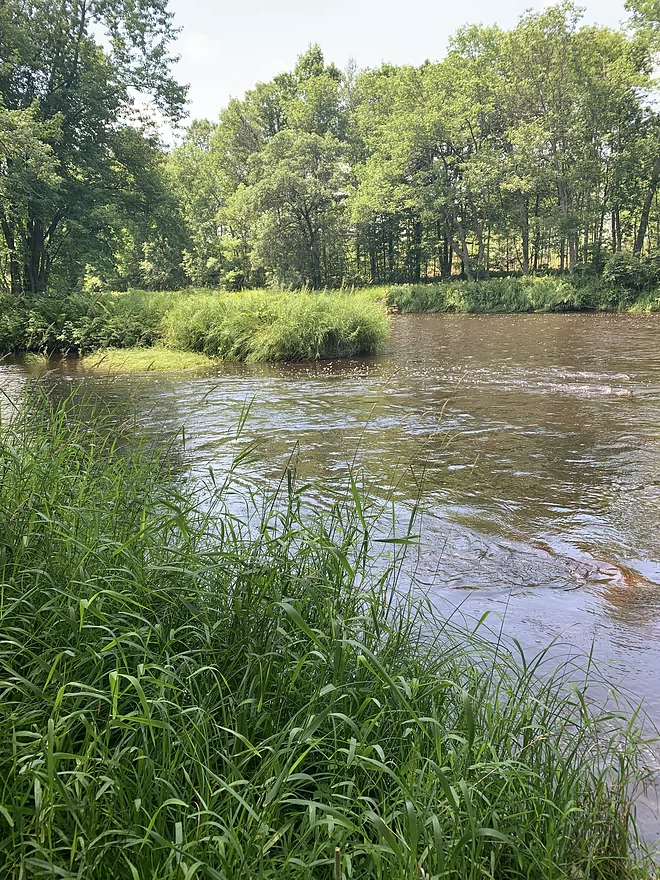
[5,0,660,295]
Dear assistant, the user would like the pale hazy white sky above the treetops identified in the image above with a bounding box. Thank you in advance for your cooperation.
[169,0,626,119]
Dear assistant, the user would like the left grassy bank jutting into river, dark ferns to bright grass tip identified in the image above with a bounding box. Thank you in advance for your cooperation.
[0,290,389,366]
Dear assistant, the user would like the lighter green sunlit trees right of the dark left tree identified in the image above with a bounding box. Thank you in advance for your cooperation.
[161,6,660,288]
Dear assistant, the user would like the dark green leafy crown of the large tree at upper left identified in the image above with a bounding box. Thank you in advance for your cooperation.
[0,0,185,296]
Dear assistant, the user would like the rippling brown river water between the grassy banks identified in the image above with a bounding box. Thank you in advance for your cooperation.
[0,315,660,836]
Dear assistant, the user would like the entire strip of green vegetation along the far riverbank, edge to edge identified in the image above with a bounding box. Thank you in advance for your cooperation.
[0,277,660,372]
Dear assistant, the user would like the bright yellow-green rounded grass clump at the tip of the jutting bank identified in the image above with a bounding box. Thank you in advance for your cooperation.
[164,290,389,361]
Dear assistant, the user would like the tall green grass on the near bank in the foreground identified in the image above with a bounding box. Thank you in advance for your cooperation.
[0,400,650,880]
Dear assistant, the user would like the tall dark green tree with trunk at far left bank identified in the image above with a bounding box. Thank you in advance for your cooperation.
[0,0,185,293]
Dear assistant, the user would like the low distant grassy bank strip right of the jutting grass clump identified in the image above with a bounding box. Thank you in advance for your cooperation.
[387,276,660,314]
